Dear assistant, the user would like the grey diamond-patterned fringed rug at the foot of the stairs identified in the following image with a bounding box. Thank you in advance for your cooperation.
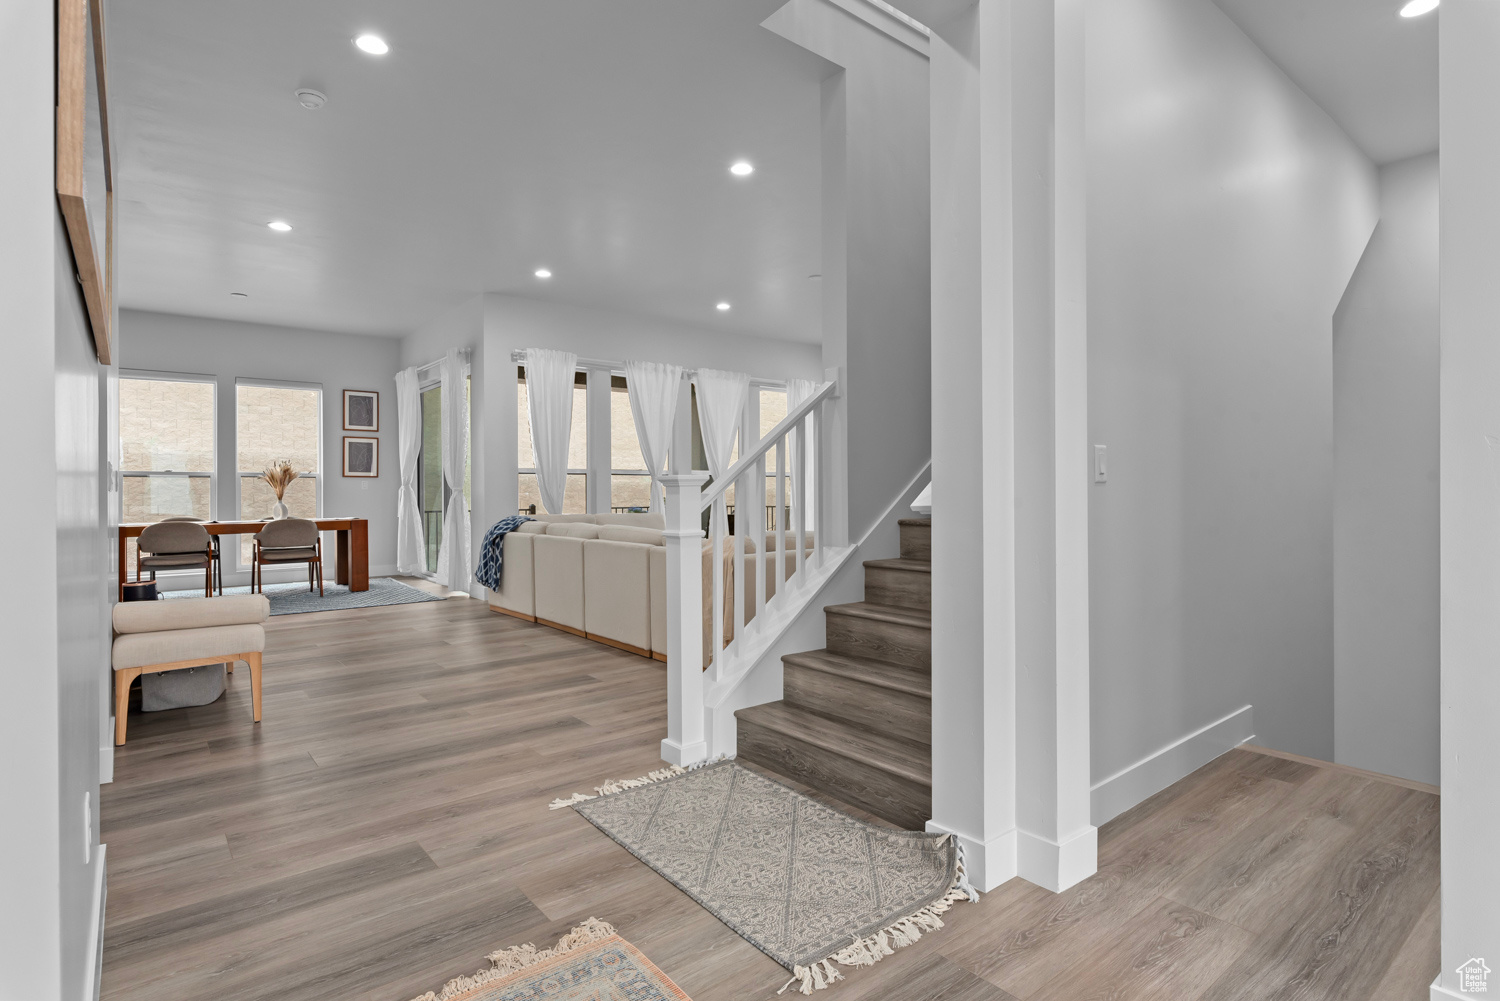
[552,761,978,993]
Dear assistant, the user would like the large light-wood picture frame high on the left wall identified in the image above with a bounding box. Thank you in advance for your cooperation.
[57,0,114,365]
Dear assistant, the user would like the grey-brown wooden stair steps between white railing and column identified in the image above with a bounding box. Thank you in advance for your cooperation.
[735,518,933,830]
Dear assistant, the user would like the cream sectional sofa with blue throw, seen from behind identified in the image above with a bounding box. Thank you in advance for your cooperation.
[486,515,810,663]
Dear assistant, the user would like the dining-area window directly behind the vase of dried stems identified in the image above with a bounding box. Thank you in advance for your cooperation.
[234,381,323,569]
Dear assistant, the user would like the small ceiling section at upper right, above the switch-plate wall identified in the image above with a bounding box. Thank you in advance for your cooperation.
[1217,0,1439,164]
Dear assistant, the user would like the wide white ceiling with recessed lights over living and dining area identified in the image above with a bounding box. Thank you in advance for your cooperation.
[110,0,830,341]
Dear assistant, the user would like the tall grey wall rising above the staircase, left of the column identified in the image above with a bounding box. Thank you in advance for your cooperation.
[764,0,932,543]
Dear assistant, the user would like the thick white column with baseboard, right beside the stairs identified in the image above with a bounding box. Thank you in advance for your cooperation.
[903,0,1097,890]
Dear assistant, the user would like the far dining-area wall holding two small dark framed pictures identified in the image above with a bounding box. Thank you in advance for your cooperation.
[120,309,401,587]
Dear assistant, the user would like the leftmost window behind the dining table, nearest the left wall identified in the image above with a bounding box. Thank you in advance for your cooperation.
[120,375,215,573]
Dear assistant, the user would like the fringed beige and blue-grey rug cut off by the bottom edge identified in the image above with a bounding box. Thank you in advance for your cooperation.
[414,917,690,1001]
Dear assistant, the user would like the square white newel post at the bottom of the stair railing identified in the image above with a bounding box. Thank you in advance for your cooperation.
[662,473,708,765]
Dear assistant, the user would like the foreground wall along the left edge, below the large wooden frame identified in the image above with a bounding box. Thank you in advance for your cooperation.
[0,3,110,1001]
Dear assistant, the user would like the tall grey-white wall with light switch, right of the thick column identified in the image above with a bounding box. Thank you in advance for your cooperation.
[1080,0,1374,821]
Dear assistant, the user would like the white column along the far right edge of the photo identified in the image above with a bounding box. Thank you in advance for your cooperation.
[1431,0,1500,1001]
